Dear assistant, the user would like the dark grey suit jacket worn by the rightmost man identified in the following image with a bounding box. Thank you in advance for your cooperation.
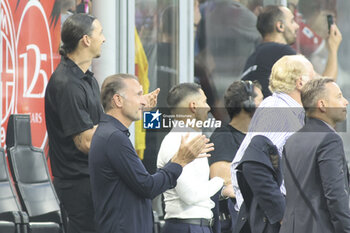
[280,118,350,233]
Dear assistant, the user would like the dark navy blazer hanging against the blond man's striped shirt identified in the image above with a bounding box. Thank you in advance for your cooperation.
[234,135,285,233]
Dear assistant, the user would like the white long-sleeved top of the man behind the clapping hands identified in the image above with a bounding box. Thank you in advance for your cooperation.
[157,126,224,219]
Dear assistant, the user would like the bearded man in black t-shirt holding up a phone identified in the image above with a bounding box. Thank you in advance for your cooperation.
[241,5,342,98]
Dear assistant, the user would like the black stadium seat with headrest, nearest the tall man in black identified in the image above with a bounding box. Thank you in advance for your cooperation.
[6,114,65,233]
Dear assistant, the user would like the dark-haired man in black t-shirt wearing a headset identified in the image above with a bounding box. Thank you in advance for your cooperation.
[208,81,263,233]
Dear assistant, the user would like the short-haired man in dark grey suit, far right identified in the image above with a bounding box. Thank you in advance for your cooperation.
[280,79,350,233]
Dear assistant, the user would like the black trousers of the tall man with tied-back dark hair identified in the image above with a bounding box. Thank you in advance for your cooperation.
[53,178,95,233]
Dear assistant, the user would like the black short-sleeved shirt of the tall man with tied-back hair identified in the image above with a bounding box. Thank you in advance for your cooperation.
[45,57,103,179]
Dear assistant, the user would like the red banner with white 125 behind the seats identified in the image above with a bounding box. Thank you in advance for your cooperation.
[0,0,61,149]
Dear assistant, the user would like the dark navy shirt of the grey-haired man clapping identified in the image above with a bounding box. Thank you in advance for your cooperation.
[89,114,182,233]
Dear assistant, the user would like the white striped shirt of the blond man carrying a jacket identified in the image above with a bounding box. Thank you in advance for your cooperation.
[231,92,305,210]
